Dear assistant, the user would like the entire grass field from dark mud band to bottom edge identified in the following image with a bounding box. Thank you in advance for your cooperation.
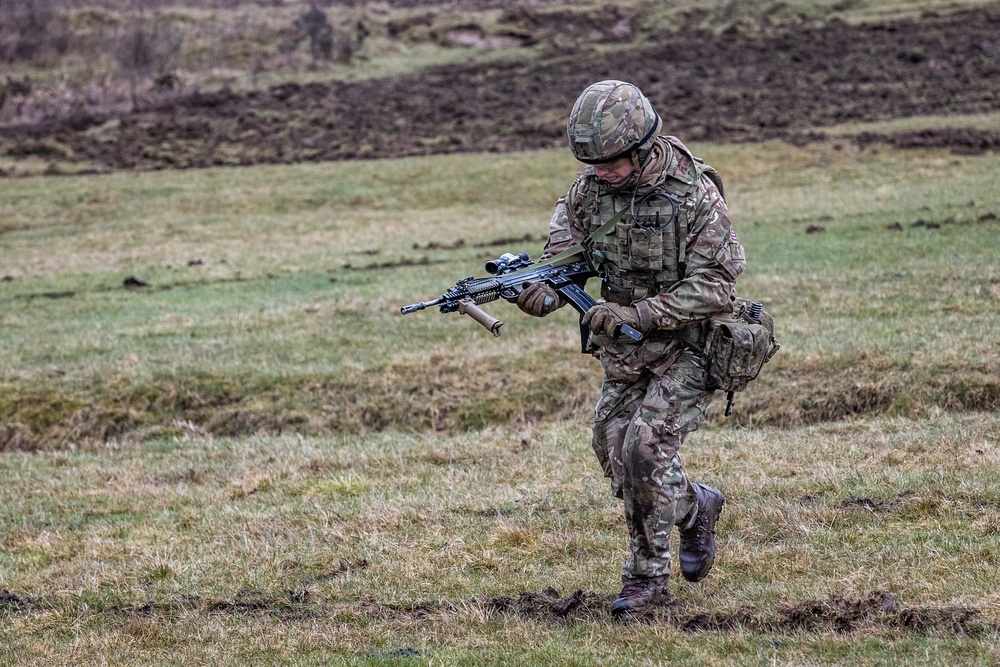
[0,134,1000,665]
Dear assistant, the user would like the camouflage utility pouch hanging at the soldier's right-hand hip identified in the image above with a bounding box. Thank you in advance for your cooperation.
[704,299,781,394]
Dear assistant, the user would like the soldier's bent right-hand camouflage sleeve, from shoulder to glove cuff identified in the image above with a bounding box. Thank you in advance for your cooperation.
[635,176,746,330]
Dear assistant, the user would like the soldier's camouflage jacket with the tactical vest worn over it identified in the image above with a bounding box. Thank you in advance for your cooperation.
[542,136,746,339]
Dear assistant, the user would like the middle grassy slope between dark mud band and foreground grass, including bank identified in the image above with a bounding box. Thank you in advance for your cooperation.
[0,138,1000,447]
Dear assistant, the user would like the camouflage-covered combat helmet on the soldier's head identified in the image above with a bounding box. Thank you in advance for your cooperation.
[566,79,661,164]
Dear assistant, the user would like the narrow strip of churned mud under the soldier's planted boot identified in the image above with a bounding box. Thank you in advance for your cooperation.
[0,588,998,640]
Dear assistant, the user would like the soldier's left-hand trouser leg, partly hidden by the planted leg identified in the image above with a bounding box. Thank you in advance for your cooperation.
[592,378,646,498]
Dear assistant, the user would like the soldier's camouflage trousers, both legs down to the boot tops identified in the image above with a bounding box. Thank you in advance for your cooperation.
[593,343,714,581]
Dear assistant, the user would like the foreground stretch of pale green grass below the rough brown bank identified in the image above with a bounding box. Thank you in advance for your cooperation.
[0,415,1000,665]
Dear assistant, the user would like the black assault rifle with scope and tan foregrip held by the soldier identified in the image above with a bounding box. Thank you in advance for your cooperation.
[400,246,642,352]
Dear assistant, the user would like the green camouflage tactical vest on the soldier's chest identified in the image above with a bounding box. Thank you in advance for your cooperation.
[583,138,722,306]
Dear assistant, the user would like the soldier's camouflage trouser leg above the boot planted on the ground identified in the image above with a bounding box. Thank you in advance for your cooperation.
[622,349,713,582]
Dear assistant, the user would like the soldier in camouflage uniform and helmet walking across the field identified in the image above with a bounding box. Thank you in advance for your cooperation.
[517,80,745,616]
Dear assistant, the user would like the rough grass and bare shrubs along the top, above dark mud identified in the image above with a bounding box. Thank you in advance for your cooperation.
[0,0,993,102]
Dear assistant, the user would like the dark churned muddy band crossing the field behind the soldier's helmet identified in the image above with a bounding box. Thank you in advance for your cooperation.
[0,7,1000,171]
